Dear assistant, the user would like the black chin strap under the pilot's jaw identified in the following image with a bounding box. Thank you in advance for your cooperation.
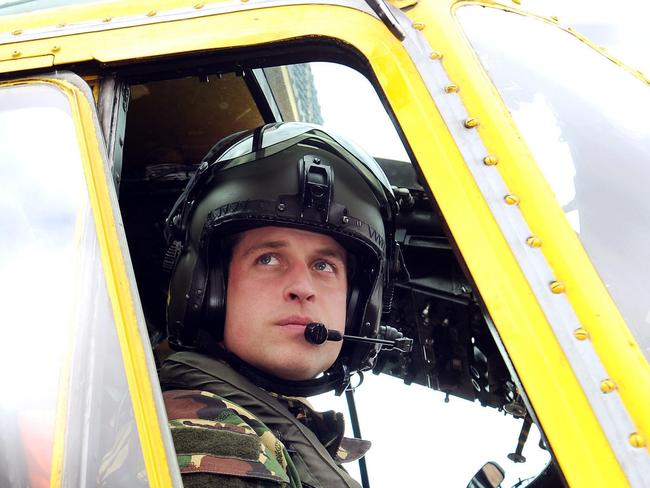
[197,330,350,397]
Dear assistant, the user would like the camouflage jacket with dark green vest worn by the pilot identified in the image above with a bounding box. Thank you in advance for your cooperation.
[159,352,370,488]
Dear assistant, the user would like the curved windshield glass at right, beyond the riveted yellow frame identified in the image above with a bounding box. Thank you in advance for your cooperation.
[458,6,650,358]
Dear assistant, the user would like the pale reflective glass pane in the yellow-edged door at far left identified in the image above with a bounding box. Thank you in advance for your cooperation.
[0,83,147,486]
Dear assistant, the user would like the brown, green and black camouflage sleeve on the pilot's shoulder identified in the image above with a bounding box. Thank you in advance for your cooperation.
[163,390,301,488]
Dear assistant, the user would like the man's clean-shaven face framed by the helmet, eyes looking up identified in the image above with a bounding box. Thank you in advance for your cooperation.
[224,227,347,380]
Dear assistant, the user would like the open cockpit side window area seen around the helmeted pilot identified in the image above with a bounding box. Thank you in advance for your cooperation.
[120,56,550,487]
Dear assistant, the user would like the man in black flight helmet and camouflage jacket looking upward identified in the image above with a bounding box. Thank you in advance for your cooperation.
[159,123,400,487]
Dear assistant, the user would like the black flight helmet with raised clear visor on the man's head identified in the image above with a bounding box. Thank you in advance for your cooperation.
[165,122,402,394]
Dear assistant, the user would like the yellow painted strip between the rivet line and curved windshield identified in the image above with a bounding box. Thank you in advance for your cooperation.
[400,1,650,480]
